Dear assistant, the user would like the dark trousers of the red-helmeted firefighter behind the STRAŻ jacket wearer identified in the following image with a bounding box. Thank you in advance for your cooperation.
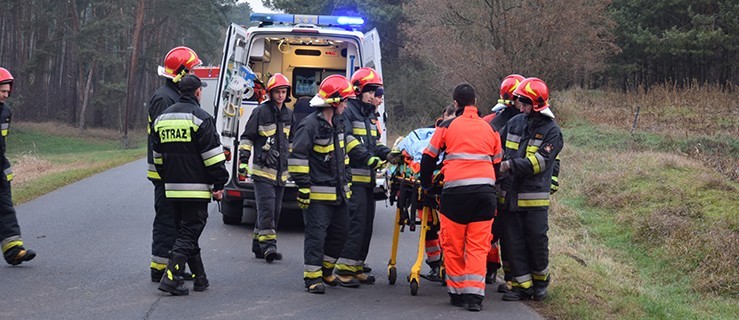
[151,181,177,263]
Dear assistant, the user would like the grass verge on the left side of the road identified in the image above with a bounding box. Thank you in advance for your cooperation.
[7,122,146,204]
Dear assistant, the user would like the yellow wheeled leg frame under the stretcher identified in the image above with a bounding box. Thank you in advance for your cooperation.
[387,172,446,296]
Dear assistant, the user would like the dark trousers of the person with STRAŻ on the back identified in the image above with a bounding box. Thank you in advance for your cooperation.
[170,200,208,257]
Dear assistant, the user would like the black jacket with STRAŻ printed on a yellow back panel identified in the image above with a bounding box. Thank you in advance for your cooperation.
[153,95,228,201]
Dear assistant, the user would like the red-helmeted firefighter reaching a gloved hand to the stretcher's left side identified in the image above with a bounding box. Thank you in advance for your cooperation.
[336,68,390,285]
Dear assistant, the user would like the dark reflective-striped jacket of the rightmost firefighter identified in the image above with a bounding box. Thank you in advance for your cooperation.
[499,112,564,211]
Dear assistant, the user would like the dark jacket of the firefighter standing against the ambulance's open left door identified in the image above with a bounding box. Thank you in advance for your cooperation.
[239,100,293,185]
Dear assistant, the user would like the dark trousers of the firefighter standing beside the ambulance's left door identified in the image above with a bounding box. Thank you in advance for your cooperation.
[254,181,285,252]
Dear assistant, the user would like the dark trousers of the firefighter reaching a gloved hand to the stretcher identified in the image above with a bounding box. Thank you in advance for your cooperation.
[336,186,375,274]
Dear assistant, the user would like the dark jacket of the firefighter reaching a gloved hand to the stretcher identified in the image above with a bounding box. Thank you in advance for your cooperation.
[342,99,390,188]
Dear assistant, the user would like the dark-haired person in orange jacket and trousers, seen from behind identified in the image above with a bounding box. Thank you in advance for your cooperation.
[420,83,502,311]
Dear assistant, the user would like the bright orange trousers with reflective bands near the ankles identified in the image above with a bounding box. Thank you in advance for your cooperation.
[439,214,493,296]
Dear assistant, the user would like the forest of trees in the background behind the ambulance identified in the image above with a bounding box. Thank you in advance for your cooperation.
[0,0,739,141]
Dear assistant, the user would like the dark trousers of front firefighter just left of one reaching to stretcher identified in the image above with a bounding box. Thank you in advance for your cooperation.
[303,201,349,280]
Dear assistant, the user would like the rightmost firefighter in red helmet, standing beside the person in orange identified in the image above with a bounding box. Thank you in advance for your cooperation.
[500,78,564,301]
